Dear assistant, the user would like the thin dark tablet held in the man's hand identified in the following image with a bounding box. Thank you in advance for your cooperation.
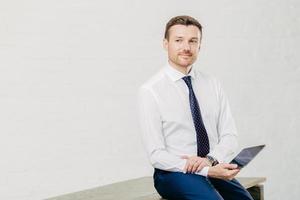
[230,144,266,168]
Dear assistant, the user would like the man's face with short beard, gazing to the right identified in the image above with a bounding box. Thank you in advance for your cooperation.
[164,25,201,68]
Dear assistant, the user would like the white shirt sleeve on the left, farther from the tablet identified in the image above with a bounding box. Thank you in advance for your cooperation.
[138,87,208,176]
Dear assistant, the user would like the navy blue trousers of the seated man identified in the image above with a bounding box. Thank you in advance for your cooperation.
[153,169,253,200]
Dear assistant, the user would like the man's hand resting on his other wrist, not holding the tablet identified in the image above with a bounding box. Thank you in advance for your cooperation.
[181,156,211,173]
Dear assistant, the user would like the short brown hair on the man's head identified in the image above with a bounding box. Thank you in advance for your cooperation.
[165,15,202,39]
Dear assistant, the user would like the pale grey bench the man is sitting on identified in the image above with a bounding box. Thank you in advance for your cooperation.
[48,177,266,200]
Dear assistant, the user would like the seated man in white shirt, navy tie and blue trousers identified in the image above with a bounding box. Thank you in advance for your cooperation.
[139,16,252,200]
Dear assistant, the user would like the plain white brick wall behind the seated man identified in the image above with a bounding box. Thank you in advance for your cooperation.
[0,0,300,200]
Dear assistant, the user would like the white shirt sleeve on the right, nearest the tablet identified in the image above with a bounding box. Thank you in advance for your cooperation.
[209,78,238,163]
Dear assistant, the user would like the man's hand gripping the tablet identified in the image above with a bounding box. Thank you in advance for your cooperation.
[208,163,240,180]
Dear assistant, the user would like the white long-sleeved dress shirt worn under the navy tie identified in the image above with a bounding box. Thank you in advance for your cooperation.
[138,64,237,176]
